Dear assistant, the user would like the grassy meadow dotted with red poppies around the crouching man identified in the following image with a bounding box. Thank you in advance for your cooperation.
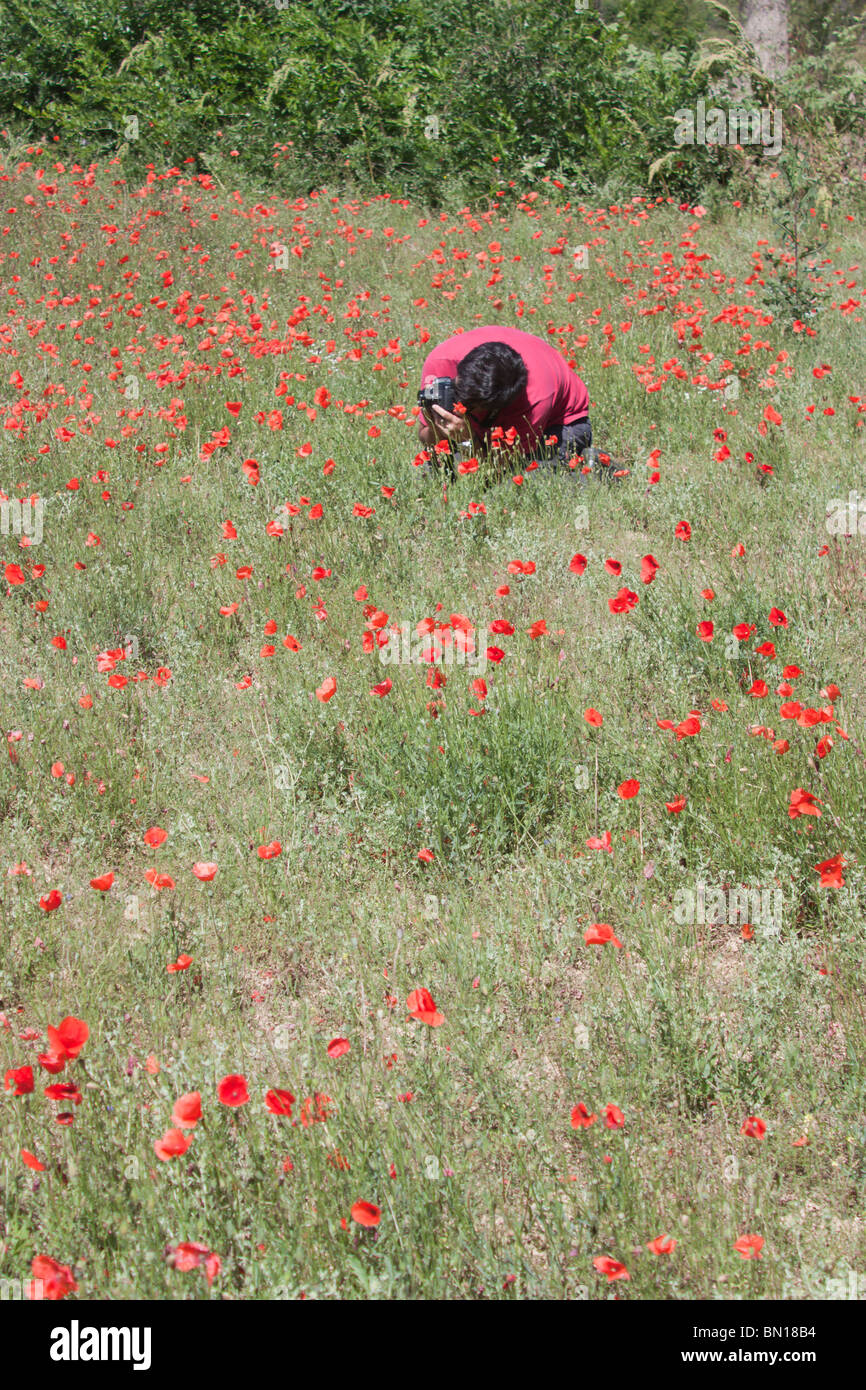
[0,154,866,1300]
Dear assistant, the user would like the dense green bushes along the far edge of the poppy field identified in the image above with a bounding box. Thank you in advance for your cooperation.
[0,0,863,203]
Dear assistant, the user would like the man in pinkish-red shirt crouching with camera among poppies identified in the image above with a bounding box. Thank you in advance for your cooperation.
[418,327,592,467]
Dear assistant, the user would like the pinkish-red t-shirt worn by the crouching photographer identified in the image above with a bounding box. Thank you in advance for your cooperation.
[421,327,589,453]
